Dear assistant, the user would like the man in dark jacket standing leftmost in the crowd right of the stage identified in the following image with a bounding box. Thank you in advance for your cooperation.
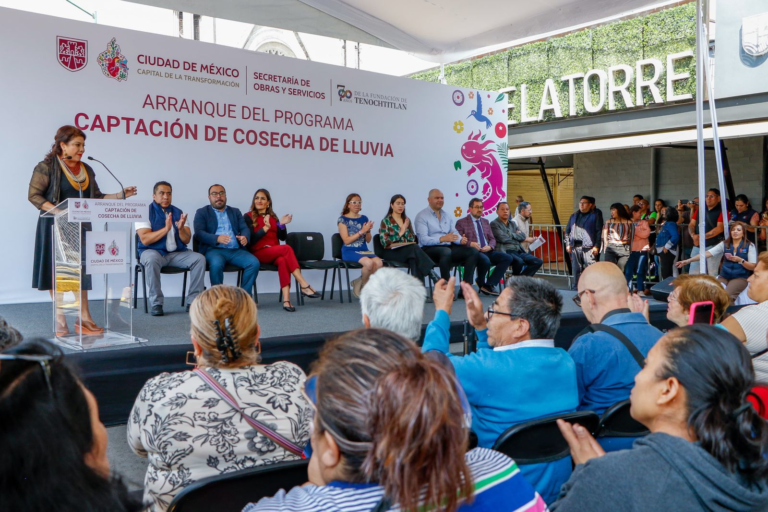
[565,196,603,290]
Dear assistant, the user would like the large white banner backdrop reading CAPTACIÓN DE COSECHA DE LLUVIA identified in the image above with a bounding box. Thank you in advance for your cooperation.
[0,9,507,303]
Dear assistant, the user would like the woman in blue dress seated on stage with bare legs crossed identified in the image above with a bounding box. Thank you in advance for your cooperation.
[336,193,384,297]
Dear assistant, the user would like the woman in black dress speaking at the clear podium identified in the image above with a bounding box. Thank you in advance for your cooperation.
[28,126,136,336]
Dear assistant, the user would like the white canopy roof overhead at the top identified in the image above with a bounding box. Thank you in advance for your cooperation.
[121,0,674,63]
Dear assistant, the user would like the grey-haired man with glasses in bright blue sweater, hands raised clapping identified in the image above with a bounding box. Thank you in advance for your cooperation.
[422,276,579,503]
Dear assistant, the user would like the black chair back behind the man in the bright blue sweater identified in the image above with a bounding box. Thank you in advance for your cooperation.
[493,411,600,466]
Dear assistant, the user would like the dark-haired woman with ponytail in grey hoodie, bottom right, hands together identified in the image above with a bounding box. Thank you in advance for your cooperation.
[550,324,768,512]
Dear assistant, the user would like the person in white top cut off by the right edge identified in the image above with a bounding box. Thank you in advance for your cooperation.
[723,252,768,384]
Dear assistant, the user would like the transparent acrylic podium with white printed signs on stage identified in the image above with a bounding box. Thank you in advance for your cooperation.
[42,198,147,351]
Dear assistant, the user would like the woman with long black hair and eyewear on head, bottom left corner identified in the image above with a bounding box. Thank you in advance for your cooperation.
[0,340,144,512]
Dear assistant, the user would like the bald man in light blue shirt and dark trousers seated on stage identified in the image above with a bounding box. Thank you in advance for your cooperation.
[416,188,480,290]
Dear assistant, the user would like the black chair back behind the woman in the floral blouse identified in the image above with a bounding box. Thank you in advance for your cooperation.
[168,460,309,512]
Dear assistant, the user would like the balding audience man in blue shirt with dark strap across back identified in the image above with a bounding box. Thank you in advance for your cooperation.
[568,261,662,414]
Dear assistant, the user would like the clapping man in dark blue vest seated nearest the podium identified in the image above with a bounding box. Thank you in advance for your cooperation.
[136,181,205,316]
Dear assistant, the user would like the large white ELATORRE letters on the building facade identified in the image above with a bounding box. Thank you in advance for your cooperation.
[499,50,693,125]
